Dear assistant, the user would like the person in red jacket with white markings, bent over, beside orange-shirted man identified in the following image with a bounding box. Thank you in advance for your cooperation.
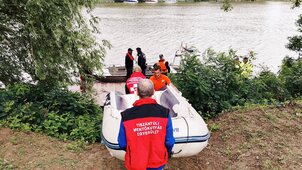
[126,66,146,94]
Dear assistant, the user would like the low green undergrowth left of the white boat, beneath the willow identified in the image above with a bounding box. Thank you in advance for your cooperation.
[0,84,101,142]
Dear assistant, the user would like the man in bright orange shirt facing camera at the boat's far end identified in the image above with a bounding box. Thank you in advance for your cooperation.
[150,64,171,91]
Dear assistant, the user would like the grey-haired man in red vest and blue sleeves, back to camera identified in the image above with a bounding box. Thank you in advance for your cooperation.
[118,79,175,170]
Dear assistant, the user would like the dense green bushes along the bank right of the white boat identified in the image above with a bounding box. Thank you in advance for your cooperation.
[172,50,302,118]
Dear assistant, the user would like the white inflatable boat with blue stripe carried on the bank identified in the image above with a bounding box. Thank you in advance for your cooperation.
[102,86,210,160]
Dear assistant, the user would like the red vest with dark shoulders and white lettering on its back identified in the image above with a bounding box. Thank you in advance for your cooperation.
[121,99,169,170]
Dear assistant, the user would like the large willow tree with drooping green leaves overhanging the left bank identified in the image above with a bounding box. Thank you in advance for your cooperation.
[0,0,110,85]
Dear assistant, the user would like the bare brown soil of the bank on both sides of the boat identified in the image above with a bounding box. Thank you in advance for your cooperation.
[0,104,302,170]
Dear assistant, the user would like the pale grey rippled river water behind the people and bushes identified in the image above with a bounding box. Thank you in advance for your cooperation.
[93,2,302,72]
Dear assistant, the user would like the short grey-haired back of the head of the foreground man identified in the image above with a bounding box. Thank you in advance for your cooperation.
[137,79,154,98]
